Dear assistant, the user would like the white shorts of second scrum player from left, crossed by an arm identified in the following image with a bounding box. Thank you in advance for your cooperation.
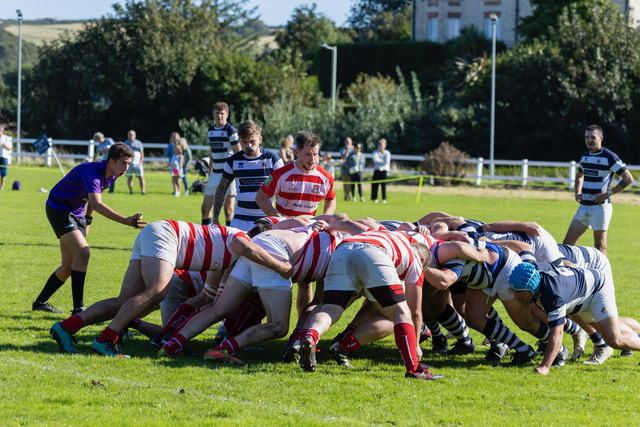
[230,233,291,292]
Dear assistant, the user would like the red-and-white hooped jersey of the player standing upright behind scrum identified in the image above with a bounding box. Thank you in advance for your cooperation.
[261,162,336,216]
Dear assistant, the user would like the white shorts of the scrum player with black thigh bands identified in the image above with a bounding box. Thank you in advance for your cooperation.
[324,242,404,301]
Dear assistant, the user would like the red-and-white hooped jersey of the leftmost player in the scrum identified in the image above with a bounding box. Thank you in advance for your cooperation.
[167,220,250,271]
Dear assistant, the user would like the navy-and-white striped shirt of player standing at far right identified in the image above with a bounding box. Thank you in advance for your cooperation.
[578,148,627,206]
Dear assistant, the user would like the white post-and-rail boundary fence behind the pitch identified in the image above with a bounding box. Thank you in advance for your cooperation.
[12,138,640,189]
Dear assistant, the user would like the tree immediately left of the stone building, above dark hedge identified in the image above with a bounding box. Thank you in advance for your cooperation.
[348,0,412,41]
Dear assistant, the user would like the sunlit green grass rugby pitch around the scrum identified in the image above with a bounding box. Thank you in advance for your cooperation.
[0,166,640,425]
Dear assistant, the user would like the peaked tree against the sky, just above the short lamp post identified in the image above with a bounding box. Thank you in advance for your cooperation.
[276,3,351,53]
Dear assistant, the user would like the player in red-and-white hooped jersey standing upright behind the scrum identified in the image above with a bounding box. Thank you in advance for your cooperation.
[256,131,336,216]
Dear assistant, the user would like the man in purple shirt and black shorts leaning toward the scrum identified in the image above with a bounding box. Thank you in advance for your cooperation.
[31,142,146,314]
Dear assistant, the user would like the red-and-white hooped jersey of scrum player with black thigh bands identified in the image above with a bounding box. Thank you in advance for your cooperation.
[342,230,436,286]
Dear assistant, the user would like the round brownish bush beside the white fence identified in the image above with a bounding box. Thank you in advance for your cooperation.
[422,141,469,185]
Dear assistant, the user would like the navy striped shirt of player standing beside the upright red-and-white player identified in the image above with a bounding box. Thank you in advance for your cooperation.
[222,150,284,221]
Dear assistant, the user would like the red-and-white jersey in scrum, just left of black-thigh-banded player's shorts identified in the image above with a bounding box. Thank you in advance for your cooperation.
[291,231,350,283]
